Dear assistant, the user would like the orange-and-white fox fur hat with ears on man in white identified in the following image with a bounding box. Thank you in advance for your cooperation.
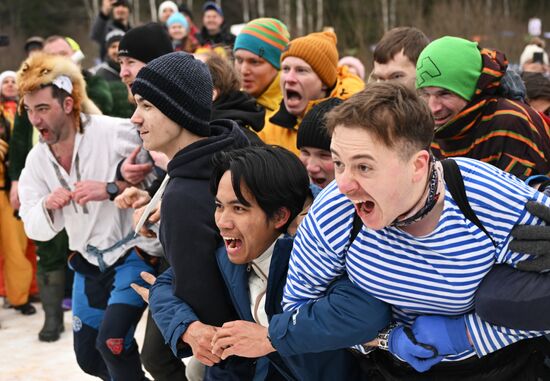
[17,52,101,131]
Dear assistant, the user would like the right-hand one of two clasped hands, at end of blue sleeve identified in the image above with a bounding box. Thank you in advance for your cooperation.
[212,320,275,360]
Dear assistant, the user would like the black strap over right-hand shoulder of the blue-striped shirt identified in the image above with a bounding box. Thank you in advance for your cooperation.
[441,159,497,247]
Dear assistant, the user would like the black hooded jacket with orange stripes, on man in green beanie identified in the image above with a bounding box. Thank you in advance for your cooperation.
[432,49,550,178]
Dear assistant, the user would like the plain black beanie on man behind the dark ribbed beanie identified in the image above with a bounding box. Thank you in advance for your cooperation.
[118,22,174,63]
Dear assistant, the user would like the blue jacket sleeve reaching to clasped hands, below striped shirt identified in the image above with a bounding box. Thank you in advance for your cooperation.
[269,276,391,356]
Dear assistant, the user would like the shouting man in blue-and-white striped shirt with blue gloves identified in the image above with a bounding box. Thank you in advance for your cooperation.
[283,83,550,379]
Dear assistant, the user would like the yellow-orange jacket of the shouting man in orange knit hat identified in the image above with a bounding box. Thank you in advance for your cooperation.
[258,67,365,155]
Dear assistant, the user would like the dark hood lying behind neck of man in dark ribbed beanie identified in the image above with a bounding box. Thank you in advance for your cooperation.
[168,119,249,180]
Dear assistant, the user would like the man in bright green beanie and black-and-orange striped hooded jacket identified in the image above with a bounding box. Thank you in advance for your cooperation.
[416,36,550,178]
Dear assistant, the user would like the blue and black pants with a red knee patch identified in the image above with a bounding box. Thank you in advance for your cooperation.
[69,249,154,381]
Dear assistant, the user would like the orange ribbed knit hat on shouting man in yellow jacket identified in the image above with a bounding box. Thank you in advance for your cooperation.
[281,32,338,87]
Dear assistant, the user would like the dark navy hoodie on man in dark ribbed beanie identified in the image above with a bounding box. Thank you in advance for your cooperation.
[160,120,249,326]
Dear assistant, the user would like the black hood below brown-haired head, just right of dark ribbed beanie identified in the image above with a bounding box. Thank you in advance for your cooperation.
[212,91,265,132]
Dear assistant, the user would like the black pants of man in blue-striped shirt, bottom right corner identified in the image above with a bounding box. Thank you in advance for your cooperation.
[359,337,550,381]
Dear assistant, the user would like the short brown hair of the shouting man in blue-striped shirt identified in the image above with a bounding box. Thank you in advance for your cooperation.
[325,82,434,159]
